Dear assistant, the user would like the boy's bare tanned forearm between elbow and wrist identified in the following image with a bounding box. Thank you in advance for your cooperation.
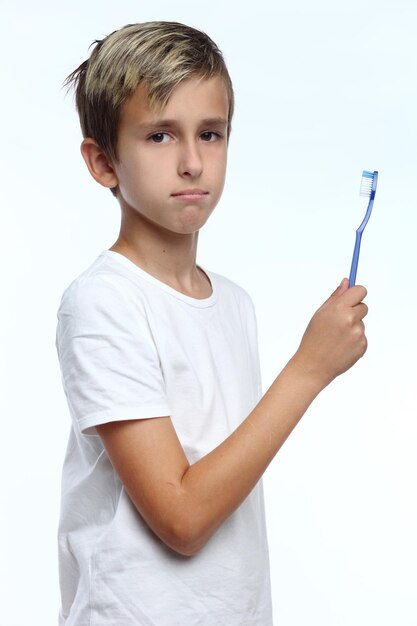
[171,359,322,554]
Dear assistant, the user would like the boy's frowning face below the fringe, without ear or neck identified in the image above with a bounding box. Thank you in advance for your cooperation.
[114,77,228,234]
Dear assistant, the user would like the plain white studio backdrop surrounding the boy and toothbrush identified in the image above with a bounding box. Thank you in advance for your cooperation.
[0,0,417,626]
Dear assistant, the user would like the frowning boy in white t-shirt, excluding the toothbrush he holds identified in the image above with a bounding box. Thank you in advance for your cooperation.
[57,22,367,626]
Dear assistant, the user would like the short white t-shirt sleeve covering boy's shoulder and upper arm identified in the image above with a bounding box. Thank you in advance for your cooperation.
[56,275,170,435]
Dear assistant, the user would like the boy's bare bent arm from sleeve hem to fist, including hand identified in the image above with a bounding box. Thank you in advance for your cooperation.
[96,279,367,555]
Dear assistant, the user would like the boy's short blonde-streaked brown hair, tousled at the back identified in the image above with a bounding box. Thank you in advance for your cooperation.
[65,22,234,160]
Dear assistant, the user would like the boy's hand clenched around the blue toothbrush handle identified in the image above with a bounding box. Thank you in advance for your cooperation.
[293,278,368,388]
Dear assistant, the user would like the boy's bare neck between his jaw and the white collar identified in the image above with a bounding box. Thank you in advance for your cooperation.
[110,214,212,299]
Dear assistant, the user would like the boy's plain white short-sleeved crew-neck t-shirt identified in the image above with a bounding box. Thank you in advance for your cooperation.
[57,251,272,626]
